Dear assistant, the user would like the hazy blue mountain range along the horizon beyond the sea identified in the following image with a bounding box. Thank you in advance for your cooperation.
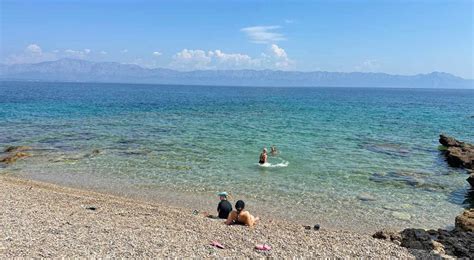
[0,59,474,89]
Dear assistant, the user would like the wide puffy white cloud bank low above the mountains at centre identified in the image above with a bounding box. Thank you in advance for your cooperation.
[170,44,293,70]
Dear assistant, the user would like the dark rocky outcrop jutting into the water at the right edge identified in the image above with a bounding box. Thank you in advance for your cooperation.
[439,135,474,170]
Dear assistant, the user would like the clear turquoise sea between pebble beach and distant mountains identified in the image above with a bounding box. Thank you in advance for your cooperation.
[0,82,474,232]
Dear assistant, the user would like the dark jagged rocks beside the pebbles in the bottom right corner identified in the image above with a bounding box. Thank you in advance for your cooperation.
[373,209,474,258]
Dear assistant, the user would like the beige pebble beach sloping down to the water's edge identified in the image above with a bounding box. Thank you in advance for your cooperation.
[0,175,429,259]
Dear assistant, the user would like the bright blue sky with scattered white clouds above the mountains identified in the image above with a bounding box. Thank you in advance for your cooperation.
[0,0,474,79]
